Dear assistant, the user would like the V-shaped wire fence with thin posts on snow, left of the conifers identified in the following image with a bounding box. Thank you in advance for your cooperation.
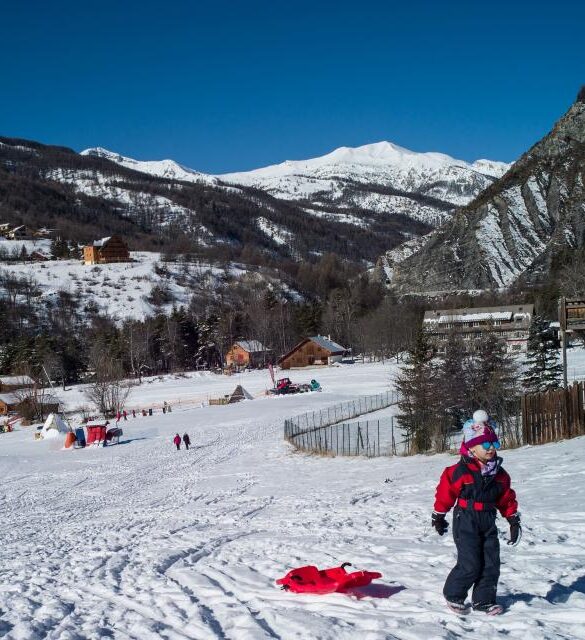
[284,391,403,457]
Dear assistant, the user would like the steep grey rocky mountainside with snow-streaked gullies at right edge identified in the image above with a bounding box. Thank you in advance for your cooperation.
[383,91,585,292]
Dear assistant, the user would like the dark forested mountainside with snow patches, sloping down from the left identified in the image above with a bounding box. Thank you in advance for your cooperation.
[0,138,420,265]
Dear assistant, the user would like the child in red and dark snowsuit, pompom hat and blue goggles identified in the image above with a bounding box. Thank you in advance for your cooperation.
[432,409,522,615]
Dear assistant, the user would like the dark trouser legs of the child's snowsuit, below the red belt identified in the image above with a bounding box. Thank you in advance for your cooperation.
[443,507,500,604]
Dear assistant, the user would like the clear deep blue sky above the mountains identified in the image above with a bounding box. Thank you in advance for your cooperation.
[0,0,585,172]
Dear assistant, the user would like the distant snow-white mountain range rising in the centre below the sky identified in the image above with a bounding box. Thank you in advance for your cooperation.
[82,142,510,227]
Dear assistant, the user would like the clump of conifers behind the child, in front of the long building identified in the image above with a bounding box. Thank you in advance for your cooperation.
[395,316,562,452]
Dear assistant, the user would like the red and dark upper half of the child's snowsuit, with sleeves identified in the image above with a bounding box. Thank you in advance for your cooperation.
[435,456,518,518]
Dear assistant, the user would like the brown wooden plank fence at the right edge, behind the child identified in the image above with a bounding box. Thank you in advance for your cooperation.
[522,382,585,444]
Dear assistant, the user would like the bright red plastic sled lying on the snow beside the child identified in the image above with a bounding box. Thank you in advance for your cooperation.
[276,562,382,593]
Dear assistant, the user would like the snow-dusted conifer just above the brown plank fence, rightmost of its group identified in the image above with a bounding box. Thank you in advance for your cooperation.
[523,316,563,393]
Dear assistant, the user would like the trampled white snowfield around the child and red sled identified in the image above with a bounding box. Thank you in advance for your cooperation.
[0,365,585,640]
